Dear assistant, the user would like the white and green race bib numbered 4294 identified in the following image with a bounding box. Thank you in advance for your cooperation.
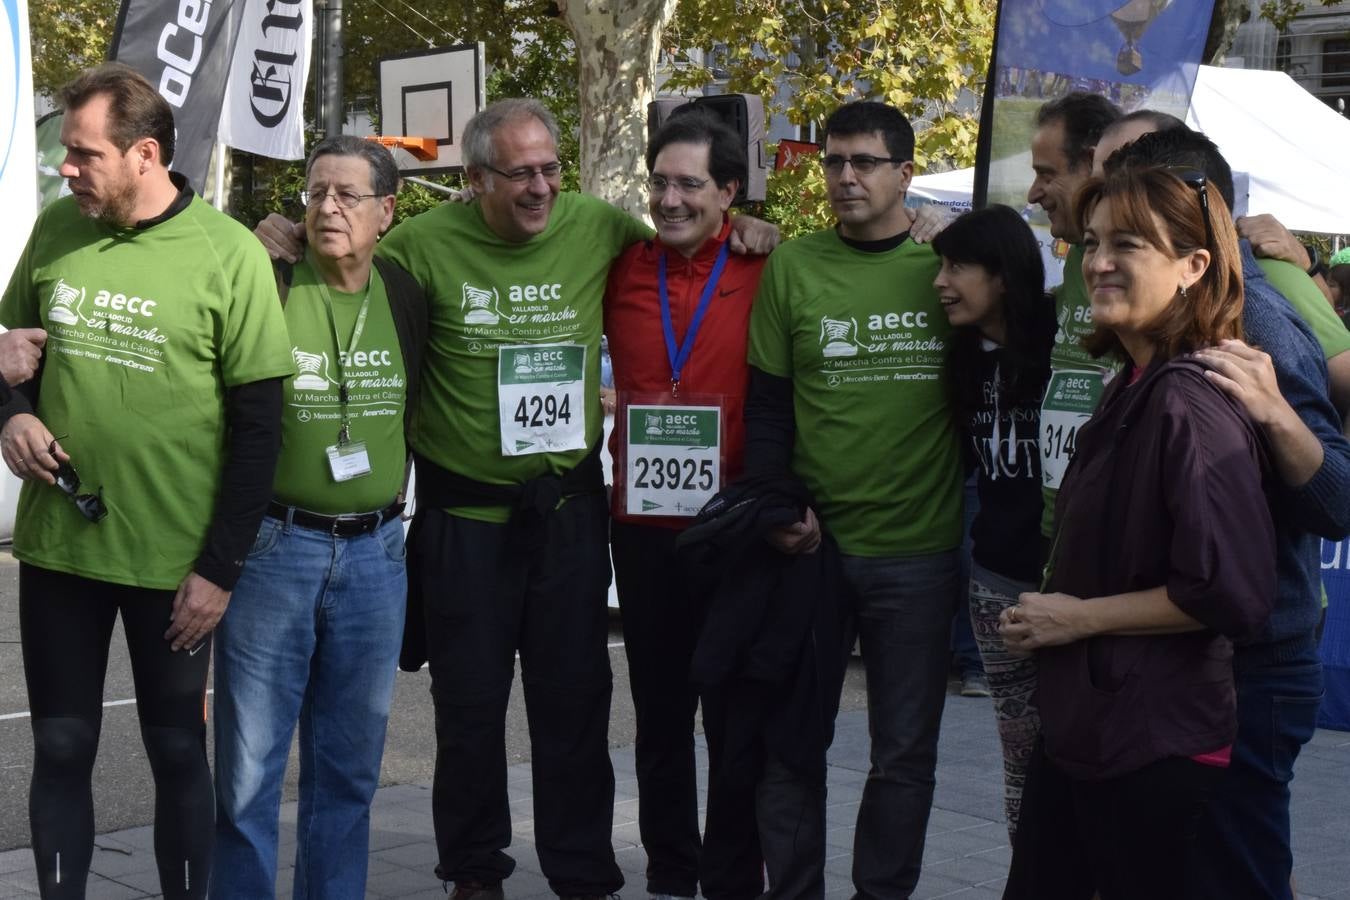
[497,344,586,456]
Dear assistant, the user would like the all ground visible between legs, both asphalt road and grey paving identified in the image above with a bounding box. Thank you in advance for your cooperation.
[0,542,1350,900]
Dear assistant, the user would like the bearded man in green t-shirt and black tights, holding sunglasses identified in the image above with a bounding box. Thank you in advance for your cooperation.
[0,63,293,897]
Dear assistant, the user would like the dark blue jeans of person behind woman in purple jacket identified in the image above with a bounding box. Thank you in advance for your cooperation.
[1188,650,1322,900]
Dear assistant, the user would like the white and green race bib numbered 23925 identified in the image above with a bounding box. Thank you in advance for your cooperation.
[624,405,722,517]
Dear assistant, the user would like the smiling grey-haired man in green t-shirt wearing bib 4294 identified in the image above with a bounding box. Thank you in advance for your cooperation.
[258,100,776,900]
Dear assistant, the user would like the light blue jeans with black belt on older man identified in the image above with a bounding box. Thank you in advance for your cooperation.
[211,518,408,900]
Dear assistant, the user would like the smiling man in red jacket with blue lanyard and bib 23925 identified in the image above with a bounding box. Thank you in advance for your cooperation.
[605,108,765,900]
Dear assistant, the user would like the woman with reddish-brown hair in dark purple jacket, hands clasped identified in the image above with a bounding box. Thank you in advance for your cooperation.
[1000,169,1274,900]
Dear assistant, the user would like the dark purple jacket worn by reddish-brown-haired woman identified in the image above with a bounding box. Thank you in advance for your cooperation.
[1037,358,1276,780]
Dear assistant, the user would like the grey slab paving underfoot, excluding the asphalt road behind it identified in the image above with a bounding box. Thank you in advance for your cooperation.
[0,696,1350,900]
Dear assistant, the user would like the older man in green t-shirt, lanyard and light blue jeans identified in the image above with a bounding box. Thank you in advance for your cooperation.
[211,135,427,900]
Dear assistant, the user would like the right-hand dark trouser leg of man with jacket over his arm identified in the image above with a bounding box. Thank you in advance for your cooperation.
[844,551,961,900]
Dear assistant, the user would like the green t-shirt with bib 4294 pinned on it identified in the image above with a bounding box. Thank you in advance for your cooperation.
[379,193,652,522]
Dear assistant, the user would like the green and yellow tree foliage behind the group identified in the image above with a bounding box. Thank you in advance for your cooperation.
[30,0,1317,235]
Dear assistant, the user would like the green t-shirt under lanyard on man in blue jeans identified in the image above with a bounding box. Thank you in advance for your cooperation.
[273,263,408,515]
